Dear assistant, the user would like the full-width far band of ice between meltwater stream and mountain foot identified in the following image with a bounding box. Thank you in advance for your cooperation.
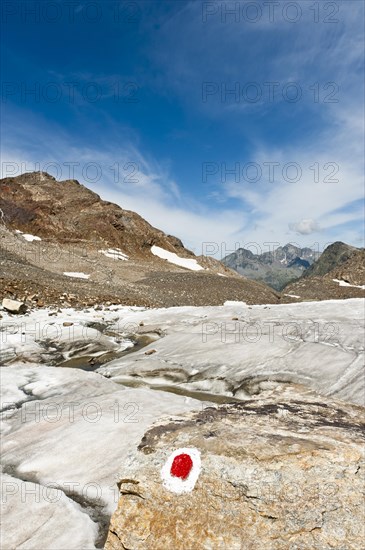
[0,298,365,403]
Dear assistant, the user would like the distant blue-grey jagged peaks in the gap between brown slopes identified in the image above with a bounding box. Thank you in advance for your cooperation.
[222,244,319,290]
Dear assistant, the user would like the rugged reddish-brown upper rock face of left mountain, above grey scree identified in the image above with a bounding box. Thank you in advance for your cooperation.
[0,172,192,257]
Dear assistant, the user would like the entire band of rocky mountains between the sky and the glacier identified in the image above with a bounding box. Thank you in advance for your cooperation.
[0,172,364,307]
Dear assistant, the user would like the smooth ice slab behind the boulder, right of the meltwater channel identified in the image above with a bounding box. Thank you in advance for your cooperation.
[96,299,365,404]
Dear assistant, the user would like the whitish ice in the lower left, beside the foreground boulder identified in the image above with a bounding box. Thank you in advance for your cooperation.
[0,365,201,550]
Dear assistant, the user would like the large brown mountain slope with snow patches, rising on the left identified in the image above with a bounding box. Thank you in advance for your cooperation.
[0,172,279,306]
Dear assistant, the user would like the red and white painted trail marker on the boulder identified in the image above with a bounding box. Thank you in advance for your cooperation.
[161,448,201,494]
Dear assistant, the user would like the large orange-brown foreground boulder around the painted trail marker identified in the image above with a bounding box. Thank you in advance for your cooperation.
[105,386,365,550]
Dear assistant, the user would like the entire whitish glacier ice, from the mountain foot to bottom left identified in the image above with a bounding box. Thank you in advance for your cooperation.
[0,299,365,550]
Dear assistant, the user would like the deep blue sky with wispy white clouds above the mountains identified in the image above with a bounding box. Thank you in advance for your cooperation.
[1,0,364,257]
